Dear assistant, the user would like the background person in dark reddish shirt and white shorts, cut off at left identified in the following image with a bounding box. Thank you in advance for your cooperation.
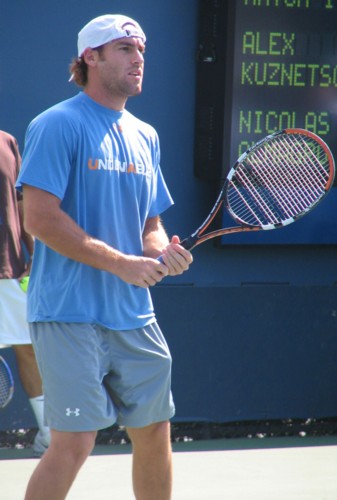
[0,130,50,456]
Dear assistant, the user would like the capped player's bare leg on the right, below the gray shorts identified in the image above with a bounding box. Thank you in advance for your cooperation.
[127,422,172,500]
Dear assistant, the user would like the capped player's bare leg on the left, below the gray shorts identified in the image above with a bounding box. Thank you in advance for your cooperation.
[25,430,96,500]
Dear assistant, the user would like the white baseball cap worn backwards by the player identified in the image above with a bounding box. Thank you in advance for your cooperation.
[77,14,146,57]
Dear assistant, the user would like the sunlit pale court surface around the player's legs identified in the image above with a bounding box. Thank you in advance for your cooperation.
[0,436,337,500]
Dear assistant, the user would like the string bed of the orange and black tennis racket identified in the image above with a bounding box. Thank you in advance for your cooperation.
[227,134,330,226]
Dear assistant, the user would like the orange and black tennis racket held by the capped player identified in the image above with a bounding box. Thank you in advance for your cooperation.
[181,128,335,250]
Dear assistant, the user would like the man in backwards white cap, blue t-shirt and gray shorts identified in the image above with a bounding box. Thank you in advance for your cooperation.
[18,15,192,500]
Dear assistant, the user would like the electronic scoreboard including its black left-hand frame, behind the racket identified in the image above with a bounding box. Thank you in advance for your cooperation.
[195,0,337,243]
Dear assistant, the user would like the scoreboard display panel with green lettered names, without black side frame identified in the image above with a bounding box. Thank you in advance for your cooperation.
[227,0,337,166]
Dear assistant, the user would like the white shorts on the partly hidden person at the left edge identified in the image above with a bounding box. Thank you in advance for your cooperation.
[0,279,32,345]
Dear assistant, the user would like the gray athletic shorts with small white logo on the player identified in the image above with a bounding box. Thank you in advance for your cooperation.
[30,322,174,432]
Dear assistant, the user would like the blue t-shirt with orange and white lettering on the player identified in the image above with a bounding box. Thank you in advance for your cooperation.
[17,92,173,330]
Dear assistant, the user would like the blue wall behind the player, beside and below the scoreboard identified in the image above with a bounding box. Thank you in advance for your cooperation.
[0,0,337,428]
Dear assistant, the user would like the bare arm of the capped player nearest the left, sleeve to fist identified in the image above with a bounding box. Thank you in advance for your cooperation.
[23,185,168,288]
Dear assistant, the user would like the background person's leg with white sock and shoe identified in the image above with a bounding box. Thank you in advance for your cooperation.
[13,344,50,456]
